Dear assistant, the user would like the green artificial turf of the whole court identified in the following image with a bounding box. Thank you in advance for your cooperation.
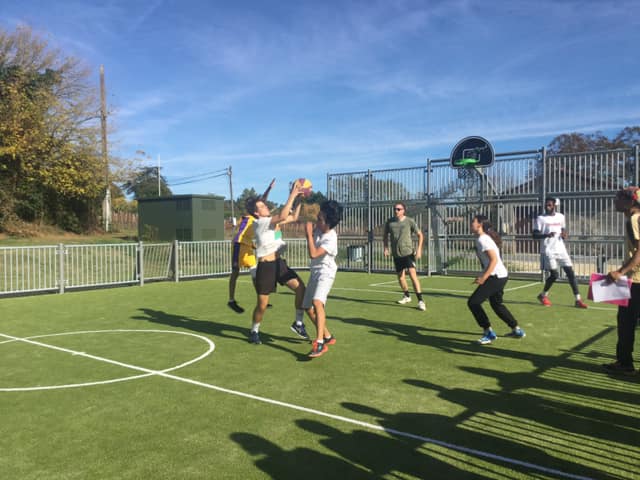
[0,272,640,479]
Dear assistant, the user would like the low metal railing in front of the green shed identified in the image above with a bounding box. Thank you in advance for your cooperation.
[0,239,316,296]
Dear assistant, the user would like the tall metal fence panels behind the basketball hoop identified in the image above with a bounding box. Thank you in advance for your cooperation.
[327,146,640,280]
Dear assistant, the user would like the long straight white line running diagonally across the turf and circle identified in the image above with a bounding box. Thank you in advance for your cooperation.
[0,333,593,480]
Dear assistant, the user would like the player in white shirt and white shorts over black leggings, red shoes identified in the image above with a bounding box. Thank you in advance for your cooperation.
[533,197,587,308]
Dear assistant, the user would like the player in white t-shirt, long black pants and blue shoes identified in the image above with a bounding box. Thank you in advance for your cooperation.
[467,215,526,345]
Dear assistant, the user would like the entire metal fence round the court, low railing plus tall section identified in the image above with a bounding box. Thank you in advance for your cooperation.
[0,146,640,296]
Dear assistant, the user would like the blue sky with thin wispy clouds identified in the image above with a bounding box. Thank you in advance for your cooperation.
[0,0,640,202]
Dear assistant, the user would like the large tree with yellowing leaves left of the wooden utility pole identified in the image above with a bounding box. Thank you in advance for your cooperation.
[0,27,105,231]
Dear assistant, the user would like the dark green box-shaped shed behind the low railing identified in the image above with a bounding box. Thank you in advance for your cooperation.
[138,195,224,241]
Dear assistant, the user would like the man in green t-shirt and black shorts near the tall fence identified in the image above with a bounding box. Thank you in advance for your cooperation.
[383,202,427,311]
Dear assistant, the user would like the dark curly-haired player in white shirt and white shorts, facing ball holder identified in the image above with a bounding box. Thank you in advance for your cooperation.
[302,200,342,357]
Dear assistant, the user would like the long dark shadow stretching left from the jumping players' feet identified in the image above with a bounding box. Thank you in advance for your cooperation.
[132,308,310,362]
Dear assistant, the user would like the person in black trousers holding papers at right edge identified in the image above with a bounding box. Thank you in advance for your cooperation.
[603,187,640,375]
